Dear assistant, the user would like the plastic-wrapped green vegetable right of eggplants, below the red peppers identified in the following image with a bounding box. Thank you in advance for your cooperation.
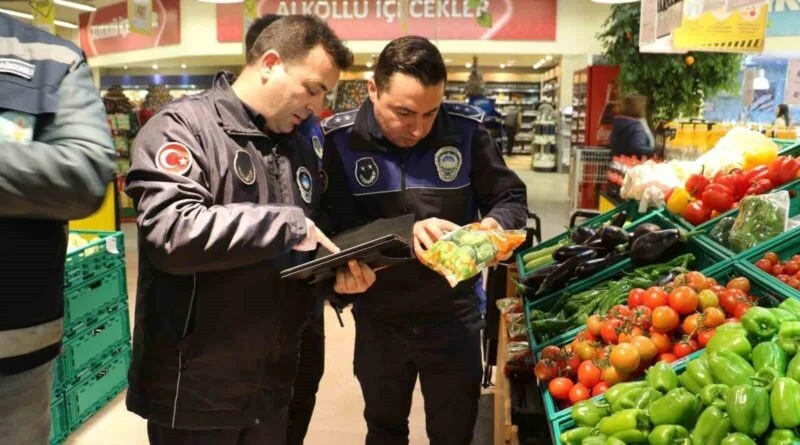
[728,190,789,253]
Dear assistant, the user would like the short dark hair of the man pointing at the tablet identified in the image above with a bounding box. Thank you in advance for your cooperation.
[247,15,353,70]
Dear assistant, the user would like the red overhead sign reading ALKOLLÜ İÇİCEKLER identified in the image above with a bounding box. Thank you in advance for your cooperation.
[217,0,557,42]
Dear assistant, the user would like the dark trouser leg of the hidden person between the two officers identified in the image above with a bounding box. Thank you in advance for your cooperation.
[286,313,325,445]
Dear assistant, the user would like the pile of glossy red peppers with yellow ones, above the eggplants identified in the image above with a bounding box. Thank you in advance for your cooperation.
[666,156,800,226]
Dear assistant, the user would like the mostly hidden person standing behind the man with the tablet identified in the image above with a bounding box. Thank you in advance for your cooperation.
[245,14,325,445]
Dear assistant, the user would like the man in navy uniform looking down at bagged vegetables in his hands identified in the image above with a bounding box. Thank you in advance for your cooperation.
[320,36,527,445]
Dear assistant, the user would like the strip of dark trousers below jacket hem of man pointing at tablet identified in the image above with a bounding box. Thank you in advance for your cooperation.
[147,408,287,445]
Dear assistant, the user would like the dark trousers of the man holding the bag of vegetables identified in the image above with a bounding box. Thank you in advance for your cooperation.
[354,316,482,445]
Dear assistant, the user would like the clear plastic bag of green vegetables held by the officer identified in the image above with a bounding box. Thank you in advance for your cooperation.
[419,223,525,287]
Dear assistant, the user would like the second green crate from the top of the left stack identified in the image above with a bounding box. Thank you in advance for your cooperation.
[64,266,128,337]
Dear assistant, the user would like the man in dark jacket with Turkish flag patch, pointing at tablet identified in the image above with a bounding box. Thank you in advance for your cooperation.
[126,16,374,445]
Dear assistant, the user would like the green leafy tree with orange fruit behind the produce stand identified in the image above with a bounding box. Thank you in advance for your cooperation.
[597,2,741,128]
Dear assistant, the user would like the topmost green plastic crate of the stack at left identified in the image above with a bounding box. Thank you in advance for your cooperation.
[64,230,125,291]
